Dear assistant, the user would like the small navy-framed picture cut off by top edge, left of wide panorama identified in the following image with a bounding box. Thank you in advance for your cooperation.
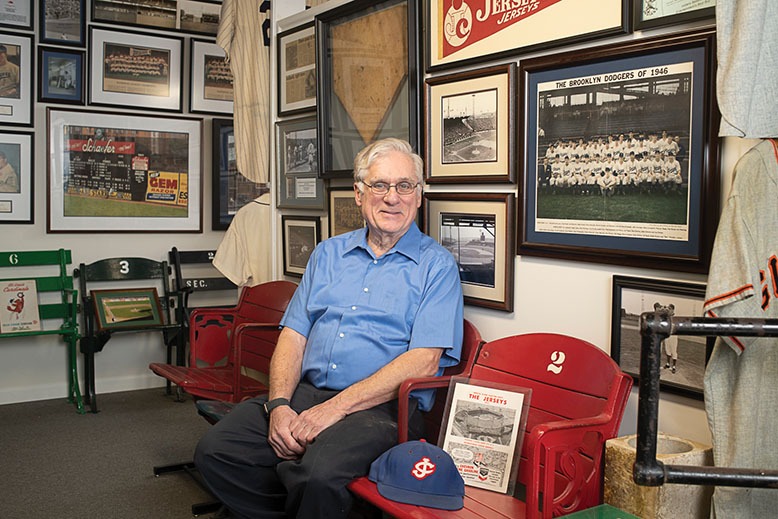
[38,0,86,47]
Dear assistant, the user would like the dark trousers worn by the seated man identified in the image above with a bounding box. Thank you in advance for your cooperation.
[195,382,423,519]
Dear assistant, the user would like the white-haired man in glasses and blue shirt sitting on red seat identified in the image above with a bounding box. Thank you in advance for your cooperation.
[195,139,463,519]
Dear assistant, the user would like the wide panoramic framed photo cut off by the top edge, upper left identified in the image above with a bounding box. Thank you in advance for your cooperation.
[92,0,221,36]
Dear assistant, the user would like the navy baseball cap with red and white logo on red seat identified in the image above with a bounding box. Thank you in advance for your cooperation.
[368,440,465,510]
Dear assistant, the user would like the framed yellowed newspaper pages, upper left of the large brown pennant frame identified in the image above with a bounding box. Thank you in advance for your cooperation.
[277,22,316,116]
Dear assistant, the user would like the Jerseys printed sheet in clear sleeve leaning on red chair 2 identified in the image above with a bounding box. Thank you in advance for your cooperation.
[442,379,531,493]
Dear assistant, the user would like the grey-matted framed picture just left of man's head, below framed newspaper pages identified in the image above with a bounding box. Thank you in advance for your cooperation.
[276,117,326,209]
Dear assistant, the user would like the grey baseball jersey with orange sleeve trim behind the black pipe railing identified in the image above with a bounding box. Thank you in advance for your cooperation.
[703,140,778,519]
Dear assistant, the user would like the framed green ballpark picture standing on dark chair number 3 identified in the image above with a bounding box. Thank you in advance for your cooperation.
[90,287,165,332]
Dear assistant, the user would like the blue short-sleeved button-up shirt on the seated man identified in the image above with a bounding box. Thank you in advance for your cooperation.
[281,224,463,410]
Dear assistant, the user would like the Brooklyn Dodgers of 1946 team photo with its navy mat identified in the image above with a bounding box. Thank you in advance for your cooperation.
[526,43,705,256]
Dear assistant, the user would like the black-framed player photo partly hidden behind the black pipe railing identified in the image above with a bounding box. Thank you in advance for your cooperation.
[611,276,715,400]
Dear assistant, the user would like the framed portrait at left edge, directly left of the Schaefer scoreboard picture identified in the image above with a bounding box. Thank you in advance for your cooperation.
[0,131,35,224]
